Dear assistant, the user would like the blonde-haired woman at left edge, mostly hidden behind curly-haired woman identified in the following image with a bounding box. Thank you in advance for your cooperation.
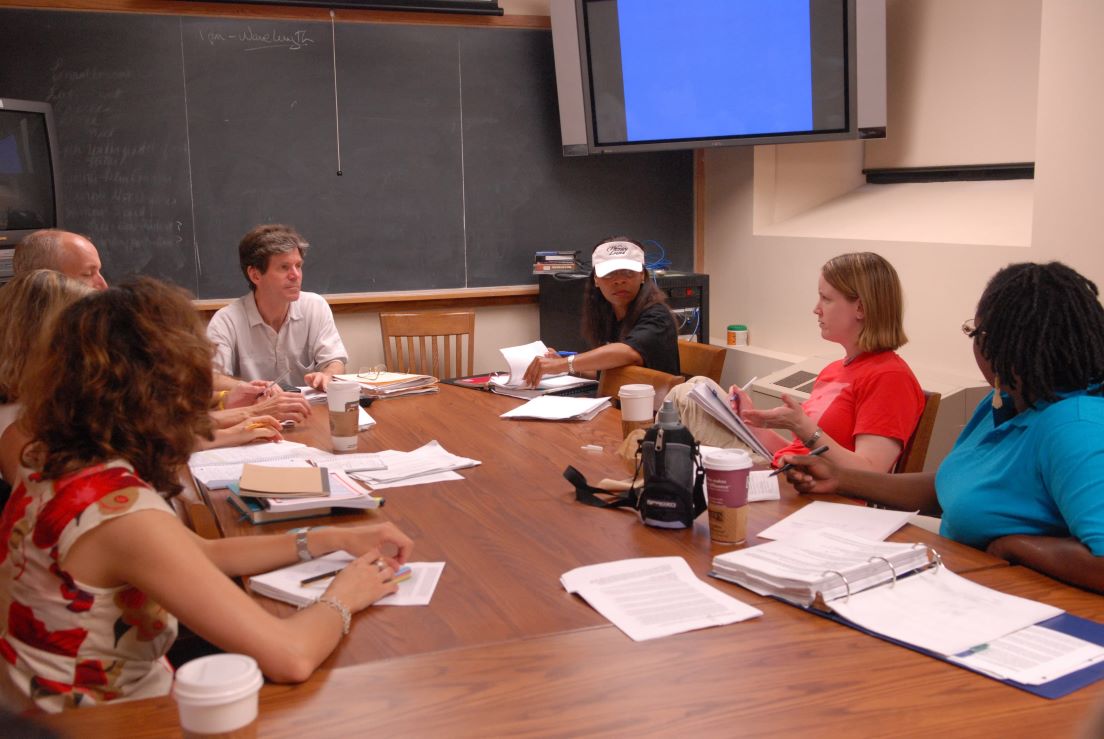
[0,270,92,483]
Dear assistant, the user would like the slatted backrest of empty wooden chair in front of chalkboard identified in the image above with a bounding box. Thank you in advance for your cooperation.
[380,310,476,379]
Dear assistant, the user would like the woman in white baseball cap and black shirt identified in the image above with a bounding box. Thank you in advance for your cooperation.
[526,236,679,386]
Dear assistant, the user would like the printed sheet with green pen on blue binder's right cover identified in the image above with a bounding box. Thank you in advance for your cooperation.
[951,626,1104,685]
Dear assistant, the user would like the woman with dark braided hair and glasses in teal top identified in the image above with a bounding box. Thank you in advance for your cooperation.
[786,262,1104,592]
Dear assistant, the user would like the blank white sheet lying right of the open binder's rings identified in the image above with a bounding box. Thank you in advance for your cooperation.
[829,567,1062,656]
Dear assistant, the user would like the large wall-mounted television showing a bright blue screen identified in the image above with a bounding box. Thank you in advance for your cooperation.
[551,0,884,156]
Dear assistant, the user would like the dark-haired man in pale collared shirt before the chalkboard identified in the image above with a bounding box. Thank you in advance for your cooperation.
[208,224,348,390]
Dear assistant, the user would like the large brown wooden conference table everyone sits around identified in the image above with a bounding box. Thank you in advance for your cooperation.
[34,386,1104,737]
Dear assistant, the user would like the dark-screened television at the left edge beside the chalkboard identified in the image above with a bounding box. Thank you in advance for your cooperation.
[0,97,61,249]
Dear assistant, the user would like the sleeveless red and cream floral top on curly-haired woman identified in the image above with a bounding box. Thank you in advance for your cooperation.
[0,461,177,711]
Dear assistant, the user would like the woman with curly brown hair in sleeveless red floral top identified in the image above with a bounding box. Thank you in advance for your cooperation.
[0,279,412,711]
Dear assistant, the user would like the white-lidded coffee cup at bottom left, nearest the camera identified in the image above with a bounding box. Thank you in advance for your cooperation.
[172,654,265,737]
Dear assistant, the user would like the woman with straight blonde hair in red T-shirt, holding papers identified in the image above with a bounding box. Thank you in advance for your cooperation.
[672,252,924,472]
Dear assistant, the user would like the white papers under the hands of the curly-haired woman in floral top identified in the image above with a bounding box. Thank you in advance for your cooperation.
[250,551,445,605]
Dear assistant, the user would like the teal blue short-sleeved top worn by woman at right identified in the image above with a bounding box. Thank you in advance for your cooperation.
[935,390,1104,557]
